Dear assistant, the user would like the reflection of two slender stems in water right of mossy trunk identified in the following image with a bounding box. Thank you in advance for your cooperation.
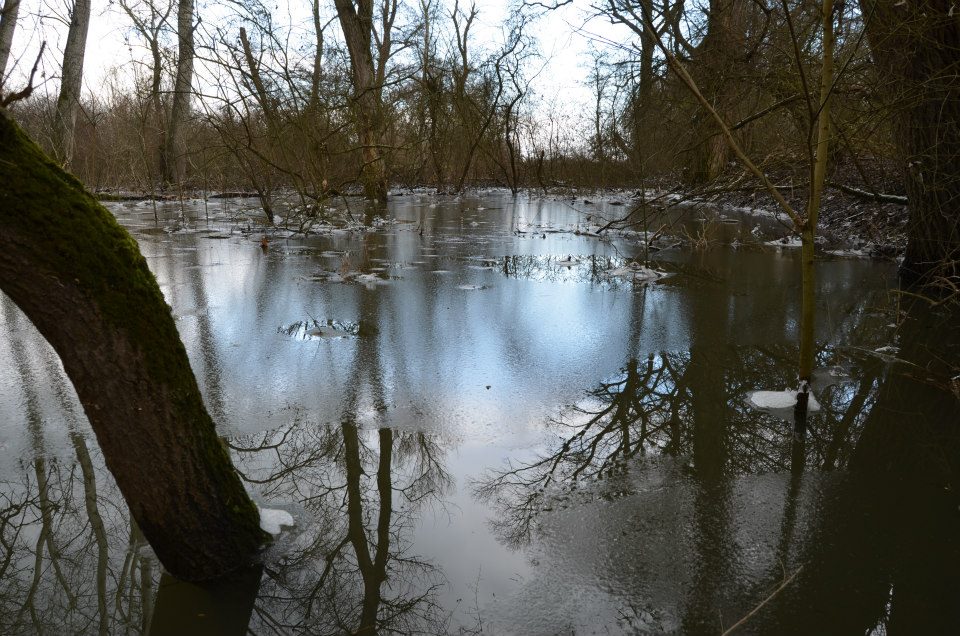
[234,422,458,634]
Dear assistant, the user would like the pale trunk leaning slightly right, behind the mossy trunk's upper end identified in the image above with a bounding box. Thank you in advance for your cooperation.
[54,0,90,166]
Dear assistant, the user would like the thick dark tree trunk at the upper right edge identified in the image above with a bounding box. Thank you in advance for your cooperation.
[860,0,960,284]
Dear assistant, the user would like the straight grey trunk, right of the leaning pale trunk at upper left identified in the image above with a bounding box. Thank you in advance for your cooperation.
[163,0,194,184]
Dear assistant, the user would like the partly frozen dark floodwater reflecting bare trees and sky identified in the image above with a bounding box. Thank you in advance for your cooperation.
[0,193,960,634]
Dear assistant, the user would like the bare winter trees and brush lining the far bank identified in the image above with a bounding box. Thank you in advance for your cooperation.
[0,0,960,281]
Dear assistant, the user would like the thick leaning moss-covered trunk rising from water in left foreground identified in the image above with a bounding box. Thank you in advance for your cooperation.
[0,112,265,580]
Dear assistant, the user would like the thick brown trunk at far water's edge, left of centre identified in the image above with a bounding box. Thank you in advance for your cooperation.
[334,0,388,202]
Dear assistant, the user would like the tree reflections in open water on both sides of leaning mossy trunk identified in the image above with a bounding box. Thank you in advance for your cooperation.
[0,414,450,634]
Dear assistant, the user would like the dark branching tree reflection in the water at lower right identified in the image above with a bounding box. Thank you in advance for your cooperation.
[474,308,960,633]
